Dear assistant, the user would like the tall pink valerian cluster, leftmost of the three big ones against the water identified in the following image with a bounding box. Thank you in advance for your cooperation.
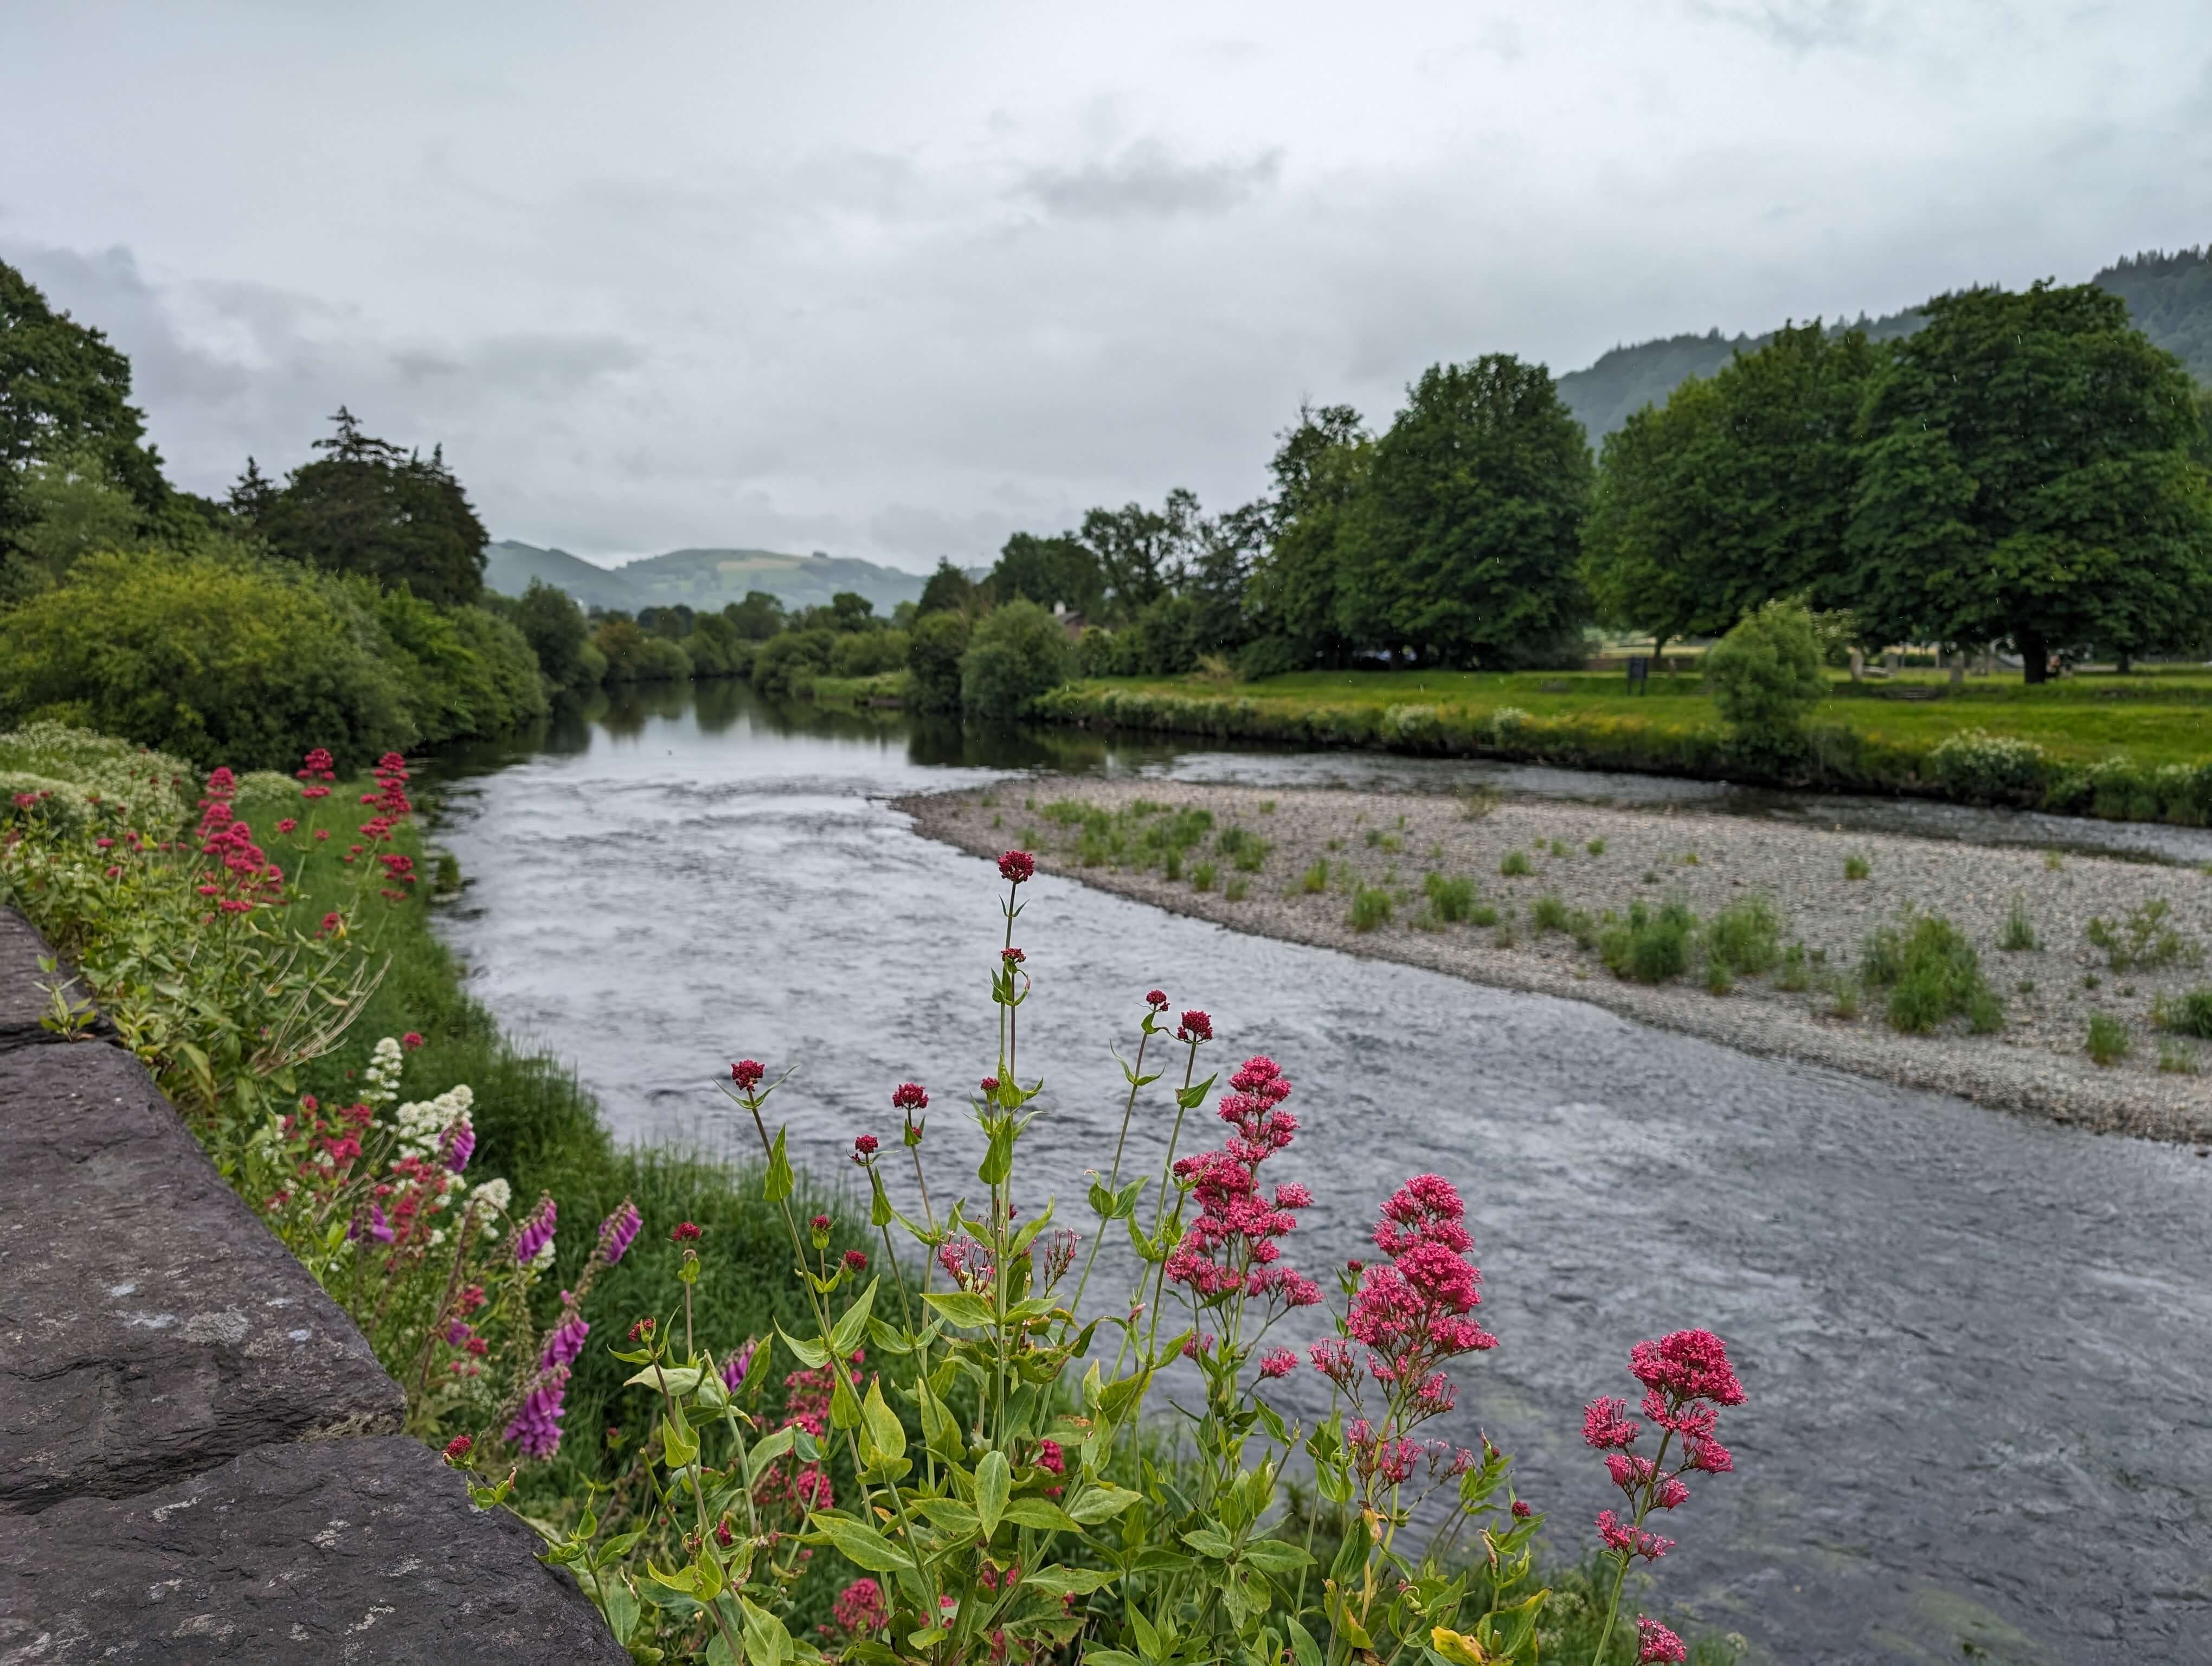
[1166,1053,1321,1308]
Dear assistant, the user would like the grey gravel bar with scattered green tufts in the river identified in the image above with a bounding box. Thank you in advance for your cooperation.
[896,779,2212,1146]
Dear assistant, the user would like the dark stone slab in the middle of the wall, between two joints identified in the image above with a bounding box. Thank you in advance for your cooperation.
[0,1042,405,1514]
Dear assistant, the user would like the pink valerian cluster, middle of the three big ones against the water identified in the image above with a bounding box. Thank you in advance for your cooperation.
[1316,1175,1497,1420]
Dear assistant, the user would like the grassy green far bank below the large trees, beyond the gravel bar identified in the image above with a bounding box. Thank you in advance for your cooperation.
[1035,670,2212,825]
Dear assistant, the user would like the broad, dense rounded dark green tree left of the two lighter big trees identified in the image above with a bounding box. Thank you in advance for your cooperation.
[1338,354,1591,666]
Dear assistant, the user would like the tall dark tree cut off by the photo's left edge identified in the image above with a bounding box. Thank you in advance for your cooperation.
[0,261,170,553]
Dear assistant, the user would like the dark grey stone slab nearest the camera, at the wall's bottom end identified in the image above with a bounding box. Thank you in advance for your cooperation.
[0,1436,628,1666]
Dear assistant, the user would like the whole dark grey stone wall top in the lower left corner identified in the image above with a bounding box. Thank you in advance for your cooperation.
[0,909,628,1666]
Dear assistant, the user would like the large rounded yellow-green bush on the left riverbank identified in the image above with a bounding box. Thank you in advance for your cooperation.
[0,551,416,768]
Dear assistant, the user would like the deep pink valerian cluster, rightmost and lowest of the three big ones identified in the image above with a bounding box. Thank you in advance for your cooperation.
[1581,1330,1743,1562]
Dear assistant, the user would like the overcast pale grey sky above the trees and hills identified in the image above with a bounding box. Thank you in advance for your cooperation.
[0,0,2212,568]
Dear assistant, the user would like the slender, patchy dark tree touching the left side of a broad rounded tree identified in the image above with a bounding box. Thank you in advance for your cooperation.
[1248,405,1374,666]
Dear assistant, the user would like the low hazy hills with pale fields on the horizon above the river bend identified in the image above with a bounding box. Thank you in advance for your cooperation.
[485,540,922,613]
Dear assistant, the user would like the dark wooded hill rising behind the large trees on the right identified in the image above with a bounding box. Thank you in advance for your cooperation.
[1559,246,2212,445]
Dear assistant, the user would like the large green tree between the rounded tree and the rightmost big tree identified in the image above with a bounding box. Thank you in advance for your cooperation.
[1584,318,1878,646]
